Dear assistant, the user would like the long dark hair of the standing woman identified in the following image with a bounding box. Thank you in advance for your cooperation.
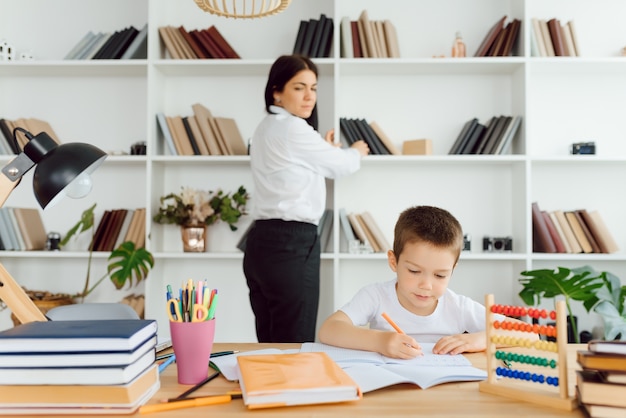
[265,55,317,130]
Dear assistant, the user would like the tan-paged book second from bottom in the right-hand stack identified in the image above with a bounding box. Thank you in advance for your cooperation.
[576,370,626,412]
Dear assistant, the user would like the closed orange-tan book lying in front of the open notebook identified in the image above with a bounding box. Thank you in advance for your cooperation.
[237,352,362,409]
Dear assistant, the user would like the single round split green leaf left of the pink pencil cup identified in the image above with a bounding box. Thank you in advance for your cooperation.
[107,241,154,289]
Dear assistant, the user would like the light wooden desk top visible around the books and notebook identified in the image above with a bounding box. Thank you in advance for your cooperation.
[4,343,584,418]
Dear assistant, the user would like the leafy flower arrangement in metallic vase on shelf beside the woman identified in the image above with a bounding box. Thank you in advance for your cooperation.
[153,186,250,252]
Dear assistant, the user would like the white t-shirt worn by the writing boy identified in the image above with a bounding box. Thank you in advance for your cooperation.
[340,279,505,343]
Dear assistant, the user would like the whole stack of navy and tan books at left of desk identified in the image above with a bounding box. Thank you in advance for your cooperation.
[0,319,160,415]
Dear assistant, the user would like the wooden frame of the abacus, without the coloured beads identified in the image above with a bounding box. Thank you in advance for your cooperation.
[478,294,578,411]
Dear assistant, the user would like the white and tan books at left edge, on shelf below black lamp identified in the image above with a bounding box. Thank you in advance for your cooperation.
[0,207,47,251]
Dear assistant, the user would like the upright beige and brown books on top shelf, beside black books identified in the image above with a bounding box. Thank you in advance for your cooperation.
[340,10,400,58]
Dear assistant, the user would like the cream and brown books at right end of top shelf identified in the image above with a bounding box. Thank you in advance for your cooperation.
[530,18,580,57]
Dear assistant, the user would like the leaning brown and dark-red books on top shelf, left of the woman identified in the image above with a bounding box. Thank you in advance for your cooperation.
[159,25,241,59]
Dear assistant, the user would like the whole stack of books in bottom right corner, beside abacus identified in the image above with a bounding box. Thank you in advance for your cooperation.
[576,340,626,418]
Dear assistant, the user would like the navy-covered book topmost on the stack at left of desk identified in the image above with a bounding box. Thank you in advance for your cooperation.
[0,319,157,353]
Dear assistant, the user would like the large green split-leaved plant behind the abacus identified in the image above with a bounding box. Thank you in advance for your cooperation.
[518,266,626,343]
